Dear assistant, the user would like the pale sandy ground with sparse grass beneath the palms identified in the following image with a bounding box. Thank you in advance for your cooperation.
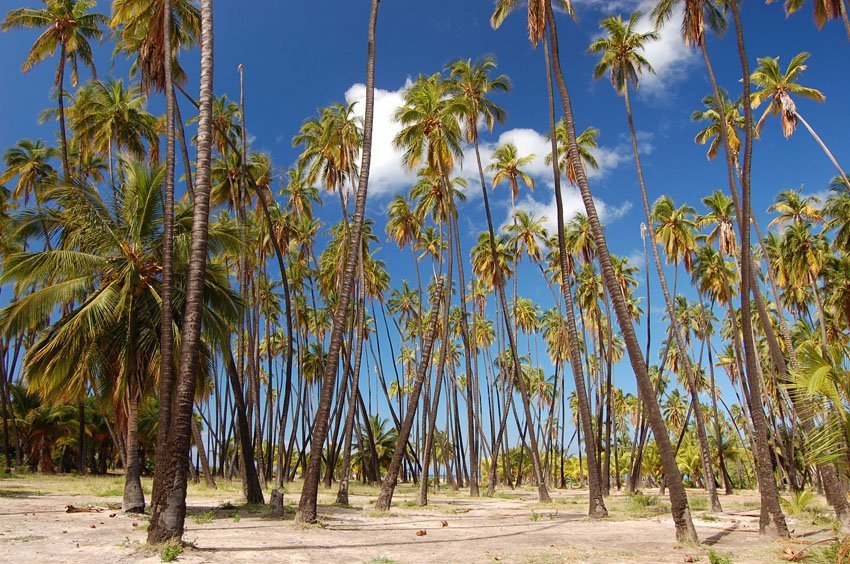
[0,476,833,564]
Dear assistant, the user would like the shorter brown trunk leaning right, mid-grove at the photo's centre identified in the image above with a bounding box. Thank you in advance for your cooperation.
[373,284,443,511]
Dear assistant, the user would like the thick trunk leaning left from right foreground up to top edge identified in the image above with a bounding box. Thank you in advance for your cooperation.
[546,0,697,542]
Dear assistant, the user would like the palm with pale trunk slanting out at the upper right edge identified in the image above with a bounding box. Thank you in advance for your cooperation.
[750,52,850,189]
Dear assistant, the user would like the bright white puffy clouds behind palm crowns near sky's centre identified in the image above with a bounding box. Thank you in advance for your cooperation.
[345,80,632,229]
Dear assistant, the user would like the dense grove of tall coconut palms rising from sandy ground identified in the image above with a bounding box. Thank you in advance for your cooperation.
[0,0,850,542]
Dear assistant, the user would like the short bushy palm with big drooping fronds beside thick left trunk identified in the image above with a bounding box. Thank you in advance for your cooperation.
[3,161,235,512]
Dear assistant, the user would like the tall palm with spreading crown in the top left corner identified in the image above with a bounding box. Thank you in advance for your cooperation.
[0,0,106,178]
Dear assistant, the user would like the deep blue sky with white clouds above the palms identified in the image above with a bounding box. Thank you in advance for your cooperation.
[0,0,850,428]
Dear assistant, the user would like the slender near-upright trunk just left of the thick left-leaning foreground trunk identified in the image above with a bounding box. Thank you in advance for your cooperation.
[543,37,608,518]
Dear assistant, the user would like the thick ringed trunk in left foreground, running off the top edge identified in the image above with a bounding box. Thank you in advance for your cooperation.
[148,0,220,543]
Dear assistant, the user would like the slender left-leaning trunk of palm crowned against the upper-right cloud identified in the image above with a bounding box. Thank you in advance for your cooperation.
[624,83,723,512]
